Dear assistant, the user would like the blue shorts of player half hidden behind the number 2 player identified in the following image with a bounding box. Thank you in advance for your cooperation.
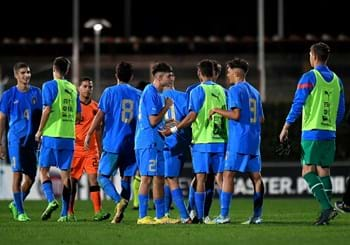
[163,150,185,177]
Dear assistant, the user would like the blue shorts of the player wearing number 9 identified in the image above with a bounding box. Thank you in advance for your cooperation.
[224,151,261,173]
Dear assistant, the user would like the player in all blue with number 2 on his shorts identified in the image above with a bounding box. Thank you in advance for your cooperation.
[135,62,180,224]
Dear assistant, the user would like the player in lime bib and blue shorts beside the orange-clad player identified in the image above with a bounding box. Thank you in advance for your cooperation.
[35,57,80,222]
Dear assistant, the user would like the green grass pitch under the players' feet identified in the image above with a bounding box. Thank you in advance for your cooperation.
[0,198,350,245]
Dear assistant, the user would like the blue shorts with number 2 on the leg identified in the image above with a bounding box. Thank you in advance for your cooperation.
[136,148,164,176]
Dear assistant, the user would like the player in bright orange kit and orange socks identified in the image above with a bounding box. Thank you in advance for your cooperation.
[68,77,110,221]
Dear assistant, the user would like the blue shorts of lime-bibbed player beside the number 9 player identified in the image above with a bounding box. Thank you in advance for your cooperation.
[192,151,225,174]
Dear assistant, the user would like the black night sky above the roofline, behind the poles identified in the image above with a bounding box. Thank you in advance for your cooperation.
[0,0,350,38]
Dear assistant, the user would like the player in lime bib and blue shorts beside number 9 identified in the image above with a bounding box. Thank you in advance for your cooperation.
[162,60,227,223]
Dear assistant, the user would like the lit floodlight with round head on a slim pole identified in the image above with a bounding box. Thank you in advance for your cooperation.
[84,19,112,93]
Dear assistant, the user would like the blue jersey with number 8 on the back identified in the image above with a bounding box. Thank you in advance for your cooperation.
[99,84,141,153]
